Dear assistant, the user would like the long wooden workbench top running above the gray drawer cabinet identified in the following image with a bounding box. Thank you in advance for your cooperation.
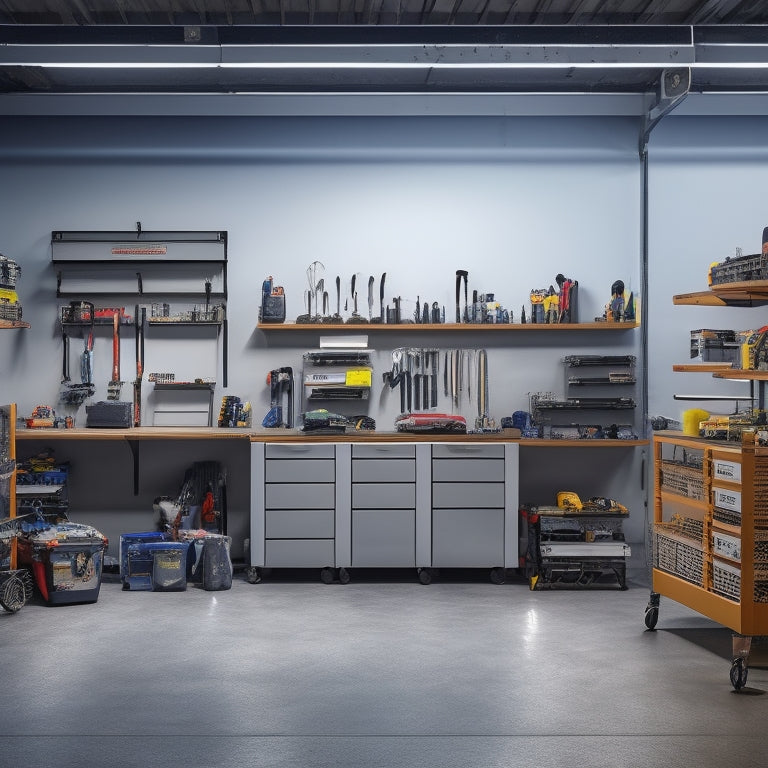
[16,427,649,448]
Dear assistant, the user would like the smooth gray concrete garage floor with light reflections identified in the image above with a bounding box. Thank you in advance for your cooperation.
[0,571,768,768]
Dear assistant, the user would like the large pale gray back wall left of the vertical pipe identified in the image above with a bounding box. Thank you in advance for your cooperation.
[0,117,644,556]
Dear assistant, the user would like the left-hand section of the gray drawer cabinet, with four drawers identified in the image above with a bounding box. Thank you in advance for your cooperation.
[248,442,349,582]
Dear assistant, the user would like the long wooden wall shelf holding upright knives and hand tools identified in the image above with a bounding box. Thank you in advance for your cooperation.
[257,322,639,333]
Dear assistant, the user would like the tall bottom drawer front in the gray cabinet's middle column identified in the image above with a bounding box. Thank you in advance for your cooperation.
[352,509,416,568]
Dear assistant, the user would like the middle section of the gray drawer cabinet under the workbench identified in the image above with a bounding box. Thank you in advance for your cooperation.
[351,443,430,568]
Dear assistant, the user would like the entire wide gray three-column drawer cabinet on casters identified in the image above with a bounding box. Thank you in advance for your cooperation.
[246,438,518,583]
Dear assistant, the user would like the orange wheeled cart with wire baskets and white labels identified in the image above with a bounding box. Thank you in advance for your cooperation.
[645,432,768,690]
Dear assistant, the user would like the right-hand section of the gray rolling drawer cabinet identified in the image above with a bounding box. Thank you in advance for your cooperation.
[431,443,518,581]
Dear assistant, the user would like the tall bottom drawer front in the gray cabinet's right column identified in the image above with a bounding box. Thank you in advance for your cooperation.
[432,509,504,568]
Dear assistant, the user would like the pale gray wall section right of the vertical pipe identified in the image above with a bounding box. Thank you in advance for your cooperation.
[646,113,768,419]
